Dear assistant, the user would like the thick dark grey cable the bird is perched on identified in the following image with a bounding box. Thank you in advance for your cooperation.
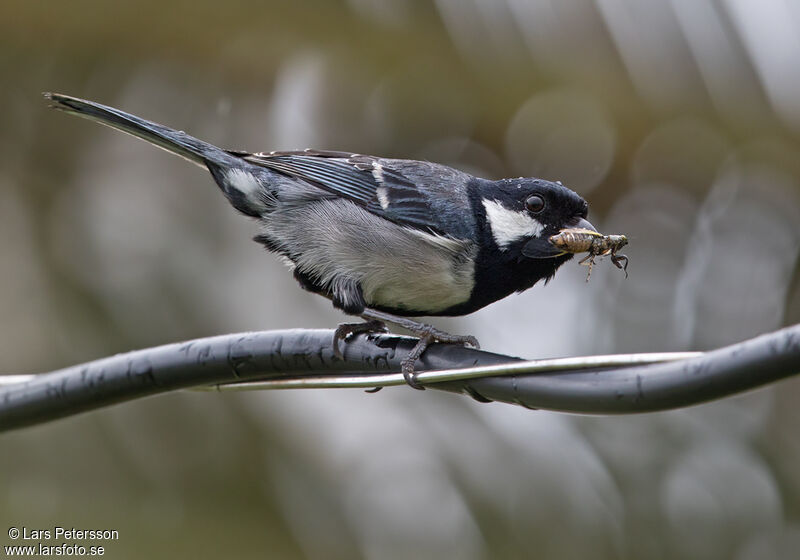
[0,325,800,432]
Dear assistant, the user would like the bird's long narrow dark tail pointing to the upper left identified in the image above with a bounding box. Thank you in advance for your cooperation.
[44,93,241,167]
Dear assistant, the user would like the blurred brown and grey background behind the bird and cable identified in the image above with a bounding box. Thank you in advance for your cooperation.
[0,0,800,560]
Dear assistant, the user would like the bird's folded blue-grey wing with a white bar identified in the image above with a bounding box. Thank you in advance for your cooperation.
[242,150,440,232]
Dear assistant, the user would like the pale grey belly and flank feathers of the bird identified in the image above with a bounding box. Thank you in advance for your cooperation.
[262,200,477,313]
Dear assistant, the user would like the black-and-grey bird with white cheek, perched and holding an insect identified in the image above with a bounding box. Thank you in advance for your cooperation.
[44,92,596,389]
